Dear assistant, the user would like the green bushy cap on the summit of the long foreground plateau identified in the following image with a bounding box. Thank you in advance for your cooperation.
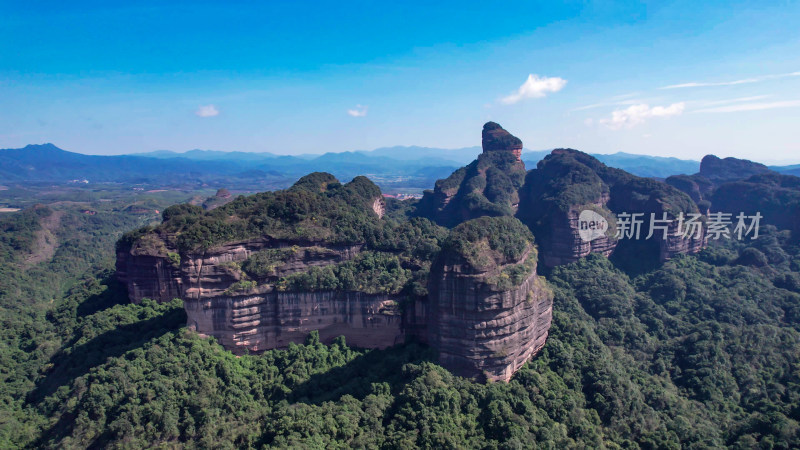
[121,173,383,255]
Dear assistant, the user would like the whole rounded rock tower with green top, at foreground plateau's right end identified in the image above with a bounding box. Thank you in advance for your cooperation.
[428,218,553,381]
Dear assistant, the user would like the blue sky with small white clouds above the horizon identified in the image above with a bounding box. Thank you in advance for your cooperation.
[0,0,800,162]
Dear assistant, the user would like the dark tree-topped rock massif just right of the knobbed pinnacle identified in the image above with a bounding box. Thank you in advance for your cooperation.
[517,149,706,267]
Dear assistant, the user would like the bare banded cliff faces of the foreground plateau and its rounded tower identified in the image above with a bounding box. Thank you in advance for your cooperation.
[117,202,552,381]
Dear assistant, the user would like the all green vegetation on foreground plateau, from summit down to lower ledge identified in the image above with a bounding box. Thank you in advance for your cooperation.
[118,172,462,295]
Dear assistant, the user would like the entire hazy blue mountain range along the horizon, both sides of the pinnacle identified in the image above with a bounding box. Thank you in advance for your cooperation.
[0,144,800,189]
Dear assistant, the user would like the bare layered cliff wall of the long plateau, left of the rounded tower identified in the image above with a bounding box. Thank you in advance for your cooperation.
[181,239,404,353]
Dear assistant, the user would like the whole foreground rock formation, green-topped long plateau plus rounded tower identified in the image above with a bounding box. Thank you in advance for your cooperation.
[117,170,552,381]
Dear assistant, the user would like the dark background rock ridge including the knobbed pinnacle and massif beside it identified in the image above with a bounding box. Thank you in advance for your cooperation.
[416,122,713,267]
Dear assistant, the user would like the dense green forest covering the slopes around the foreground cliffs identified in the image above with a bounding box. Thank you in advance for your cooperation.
[0,192,800,449]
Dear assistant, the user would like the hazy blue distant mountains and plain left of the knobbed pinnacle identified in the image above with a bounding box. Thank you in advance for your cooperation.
[0,144,457,190]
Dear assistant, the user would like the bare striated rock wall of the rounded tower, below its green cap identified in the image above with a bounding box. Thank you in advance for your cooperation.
[428,221,553,381]
